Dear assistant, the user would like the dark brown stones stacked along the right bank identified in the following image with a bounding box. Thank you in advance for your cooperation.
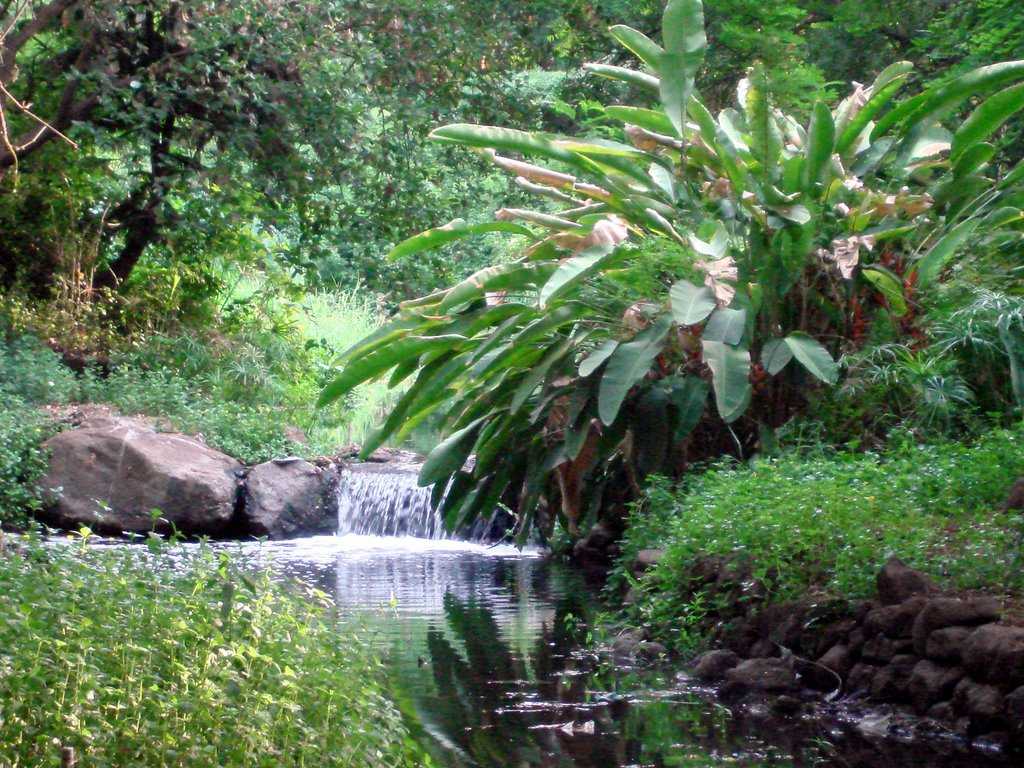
[693,558,1024,743]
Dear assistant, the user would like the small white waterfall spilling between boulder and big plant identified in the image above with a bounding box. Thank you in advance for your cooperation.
[338,464,449,540]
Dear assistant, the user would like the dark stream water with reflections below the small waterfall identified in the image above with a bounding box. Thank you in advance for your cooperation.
[184,536,1014,768]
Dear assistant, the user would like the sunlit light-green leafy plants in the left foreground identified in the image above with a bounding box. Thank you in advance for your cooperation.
[0,545,430,768]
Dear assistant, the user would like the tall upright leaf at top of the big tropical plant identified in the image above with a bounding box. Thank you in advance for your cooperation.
[658,0,708,138]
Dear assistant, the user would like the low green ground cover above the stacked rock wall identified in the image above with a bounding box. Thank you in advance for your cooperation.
[618,426,1024,651]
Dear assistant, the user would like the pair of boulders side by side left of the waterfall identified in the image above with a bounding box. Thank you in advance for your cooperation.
[42,417,339,539]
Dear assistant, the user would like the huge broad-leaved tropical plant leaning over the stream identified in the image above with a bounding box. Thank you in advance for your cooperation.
[321,0,1024,536]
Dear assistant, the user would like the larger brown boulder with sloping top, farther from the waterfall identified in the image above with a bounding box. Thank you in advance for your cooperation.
[42,418,242,535]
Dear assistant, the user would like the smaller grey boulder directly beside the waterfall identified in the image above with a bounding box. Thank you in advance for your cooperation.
[241,459,338,539]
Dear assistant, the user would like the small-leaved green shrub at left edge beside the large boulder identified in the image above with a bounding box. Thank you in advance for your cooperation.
[0,396,54,527]
